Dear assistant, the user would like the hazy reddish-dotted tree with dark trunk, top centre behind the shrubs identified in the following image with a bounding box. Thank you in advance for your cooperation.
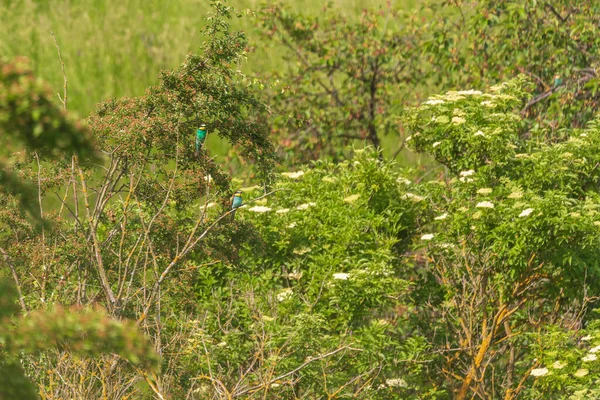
[261,4,427,164]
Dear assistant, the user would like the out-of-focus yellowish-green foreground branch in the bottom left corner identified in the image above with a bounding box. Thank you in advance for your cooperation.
[0,280,160,400]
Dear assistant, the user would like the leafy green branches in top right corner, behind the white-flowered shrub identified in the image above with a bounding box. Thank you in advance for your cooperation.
[425,0,600,136]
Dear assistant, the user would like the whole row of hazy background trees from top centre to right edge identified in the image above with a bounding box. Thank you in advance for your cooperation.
[261,0,600,162]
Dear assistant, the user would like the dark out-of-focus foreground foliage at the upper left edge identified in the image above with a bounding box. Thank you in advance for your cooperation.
[0,59,99,222]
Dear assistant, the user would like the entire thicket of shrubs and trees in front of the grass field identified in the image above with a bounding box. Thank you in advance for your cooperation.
[0,0,600,399]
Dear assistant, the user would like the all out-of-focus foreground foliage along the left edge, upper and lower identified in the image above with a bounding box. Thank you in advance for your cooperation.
[0,56,159,399]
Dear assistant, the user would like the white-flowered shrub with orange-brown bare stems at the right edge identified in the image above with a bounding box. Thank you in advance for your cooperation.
[407,77,600,399]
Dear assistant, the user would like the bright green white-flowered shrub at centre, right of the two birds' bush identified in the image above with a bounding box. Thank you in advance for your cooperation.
[184,150,426,399]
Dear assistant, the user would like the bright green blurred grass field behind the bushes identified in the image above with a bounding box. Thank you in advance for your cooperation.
[0,0,418,168]
